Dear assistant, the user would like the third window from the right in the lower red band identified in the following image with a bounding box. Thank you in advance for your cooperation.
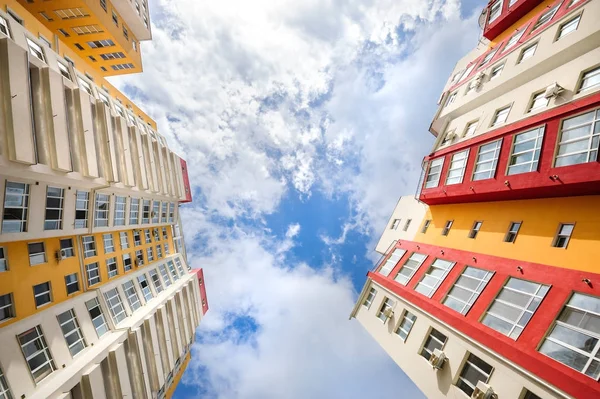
[443,266,494,315]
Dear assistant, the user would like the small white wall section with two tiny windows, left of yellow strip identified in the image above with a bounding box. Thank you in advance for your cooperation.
[375,195,427,255]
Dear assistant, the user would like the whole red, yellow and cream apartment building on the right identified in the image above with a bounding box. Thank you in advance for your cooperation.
[351,0,600,399]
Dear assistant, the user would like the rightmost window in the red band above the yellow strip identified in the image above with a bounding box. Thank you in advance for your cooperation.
[554,109,600,167]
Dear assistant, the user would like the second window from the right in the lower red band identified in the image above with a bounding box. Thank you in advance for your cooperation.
[481,277,550,339]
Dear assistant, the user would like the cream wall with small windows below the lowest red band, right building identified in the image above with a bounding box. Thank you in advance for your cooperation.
[355,280,570,399]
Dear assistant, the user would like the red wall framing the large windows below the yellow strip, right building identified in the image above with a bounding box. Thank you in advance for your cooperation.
[368,241,600,398]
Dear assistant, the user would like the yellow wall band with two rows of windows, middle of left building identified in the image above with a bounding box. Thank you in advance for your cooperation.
[0,225,175,326]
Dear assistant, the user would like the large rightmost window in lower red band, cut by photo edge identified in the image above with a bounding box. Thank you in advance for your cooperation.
[539,292,600,380]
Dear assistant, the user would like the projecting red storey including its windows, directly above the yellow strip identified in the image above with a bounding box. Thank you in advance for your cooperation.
[419,94,600,205]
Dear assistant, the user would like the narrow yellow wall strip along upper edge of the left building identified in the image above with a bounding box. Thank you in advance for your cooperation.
[0,0,157,130]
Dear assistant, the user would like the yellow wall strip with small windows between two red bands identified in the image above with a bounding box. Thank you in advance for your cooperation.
[415,196,600,273]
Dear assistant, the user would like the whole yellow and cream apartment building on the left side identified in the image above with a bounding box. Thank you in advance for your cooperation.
[0,0,208,399]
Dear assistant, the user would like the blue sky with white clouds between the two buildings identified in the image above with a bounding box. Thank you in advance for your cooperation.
[113,0,484,399]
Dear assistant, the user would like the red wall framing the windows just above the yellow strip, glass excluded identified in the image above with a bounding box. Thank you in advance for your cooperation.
[420,93,600,205]
